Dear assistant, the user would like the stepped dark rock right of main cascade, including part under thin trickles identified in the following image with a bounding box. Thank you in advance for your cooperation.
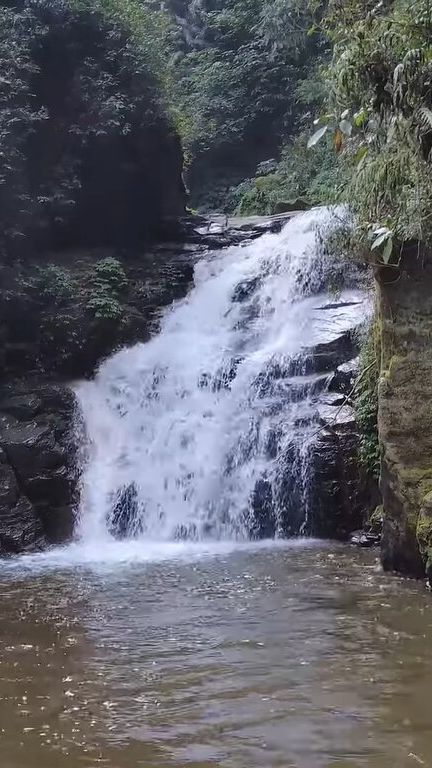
[251,291,378,540]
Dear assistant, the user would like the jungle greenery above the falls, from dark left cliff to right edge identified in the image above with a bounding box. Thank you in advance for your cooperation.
[174,0,432,262]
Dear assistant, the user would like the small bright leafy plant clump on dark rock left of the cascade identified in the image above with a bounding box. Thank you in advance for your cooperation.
[87,257,127,323]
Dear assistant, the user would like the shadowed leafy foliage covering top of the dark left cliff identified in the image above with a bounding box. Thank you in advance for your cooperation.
[0,0,176,255]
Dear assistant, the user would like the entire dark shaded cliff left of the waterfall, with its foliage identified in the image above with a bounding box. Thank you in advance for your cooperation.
[0,0,192,554]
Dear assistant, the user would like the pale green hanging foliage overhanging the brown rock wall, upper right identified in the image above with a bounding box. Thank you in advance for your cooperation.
[312,0,432,254]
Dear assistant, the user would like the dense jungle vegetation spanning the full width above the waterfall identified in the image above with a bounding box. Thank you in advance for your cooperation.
[0,0,432,240]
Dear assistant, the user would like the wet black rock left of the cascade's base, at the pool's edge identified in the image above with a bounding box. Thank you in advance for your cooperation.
[0,383,78,554]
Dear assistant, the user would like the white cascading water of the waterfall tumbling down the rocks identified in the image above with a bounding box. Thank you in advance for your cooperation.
[77,209,362,542]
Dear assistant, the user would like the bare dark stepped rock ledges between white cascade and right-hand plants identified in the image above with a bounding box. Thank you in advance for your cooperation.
[296,296,377,540]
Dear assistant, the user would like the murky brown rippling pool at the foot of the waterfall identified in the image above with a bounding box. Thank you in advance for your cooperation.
[0,544,432,768]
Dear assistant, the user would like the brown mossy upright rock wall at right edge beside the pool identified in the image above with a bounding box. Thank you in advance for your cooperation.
[378,251,432,577]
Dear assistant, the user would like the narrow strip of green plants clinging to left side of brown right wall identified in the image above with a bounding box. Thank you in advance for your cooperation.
[354,323,380,478]
